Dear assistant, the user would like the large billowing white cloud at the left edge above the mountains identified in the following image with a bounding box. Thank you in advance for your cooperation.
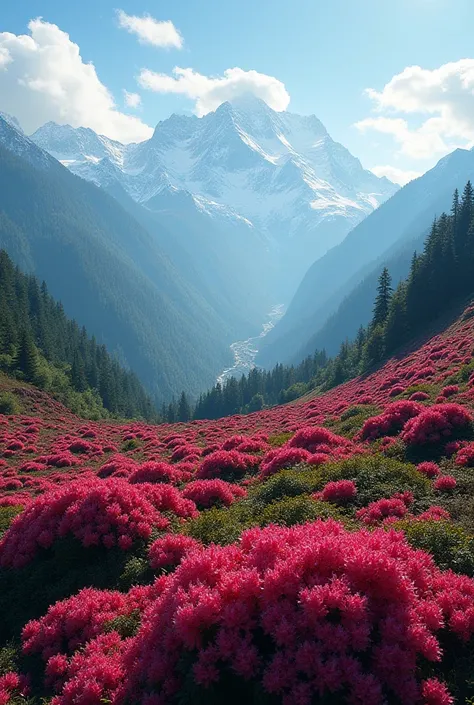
[0,18,153,142]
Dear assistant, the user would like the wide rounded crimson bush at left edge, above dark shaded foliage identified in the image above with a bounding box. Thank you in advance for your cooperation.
[0,479,169,568]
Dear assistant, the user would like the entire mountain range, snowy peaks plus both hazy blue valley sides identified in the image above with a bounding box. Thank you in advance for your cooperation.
[7,96,474,408]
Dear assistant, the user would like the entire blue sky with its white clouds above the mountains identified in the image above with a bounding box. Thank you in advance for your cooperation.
[0,0,474,180]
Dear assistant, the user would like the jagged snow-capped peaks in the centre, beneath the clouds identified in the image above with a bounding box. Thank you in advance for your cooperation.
[32,96,397,284]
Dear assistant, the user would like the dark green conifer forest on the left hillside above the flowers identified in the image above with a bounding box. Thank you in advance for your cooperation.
[0,250,157,419]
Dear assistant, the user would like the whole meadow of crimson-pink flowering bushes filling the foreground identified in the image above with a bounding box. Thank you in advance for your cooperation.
[0,308,474,705]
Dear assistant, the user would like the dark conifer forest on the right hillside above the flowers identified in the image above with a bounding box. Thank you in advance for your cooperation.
[193,181,474,421]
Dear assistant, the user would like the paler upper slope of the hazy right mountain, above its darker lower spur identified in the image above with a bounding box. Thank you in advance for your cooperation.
[257,149,474,366]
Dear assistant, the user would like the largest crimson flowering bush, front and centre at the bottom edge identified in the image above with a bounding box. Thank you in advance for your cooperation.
[116,521,474,705]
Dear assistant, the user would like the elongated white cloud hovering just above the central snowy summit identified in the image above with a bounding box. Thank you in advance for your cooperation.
[138,66,290,116]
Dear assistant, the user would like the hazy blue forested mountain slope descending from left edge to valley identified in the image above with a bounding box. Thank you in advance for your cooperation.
[0,119,232,401]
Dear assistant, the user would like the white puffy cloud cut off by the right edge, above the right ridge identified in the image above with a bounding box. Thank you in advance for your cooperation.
[356,59,474,159]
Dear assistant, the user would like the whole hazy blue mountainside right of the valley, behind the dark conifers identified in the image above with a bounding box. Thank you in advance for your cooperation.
[257,149,474,367]
